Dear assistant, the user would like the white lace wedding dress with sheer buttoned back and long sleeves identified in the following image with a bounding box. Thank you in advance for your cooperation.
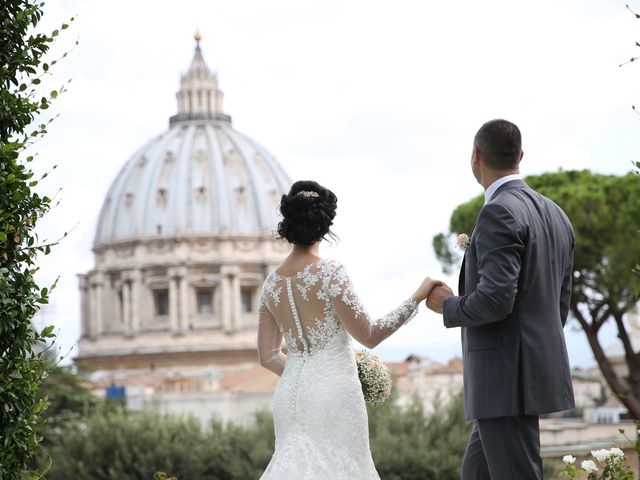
[258,259,417,480]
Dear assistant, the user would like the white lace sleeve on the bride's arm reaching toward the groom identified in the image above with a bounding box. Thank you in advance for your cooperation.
[329,265,418,348]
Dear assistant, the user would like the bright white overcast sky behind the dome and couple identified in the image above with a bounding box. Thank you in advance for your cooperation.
[34,0,640,366]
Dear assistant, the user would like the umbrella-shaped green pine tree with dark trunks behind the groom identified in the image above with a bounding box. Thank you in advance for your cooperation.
[433,170,640,420]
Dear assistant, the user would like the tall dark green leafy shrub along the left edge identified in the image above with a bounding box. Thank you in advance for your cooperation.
[0,0,74,480]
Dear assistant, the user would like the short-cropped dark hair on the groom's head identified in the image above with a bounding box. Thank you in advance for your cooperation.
[473,119,522,170]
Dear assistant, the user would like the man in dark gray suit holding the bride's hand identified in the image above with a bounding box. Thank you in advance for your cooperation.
[427,120,574,480]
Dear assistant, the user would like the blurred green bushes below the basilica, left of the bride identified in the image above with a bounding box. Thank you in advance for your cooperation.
[39,405,274,480]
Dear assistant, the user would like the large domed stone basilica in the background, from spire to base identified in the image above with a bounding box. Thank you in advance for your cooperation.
[76,35,291,420]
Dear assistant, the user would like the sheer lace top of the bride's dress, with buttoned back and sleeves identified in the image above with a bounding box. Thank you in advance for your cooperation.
[258,259,417,372]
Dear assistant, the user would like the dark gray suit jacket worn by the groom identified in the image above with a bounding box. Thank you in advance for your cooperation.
[444,180,575,419]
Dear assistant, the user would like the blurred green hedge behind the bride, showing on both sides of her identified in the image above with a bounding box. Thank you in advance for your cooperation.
[42,395,470,480]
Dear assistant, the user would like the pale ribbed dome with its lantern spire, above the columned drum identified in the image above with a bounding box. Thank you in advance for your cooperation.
[94,39,291,247]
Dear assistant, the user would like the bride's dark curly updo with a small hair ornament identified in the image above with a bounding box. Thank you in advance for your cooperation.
[278,180,338,246]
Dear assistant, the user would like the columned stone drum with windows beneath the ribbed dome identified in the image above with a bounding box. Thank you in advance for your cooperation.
[78,238,287,367]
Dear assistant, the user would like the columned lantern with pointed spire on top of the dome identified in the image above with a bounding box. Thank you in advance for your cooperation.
[169,32,231,125]
